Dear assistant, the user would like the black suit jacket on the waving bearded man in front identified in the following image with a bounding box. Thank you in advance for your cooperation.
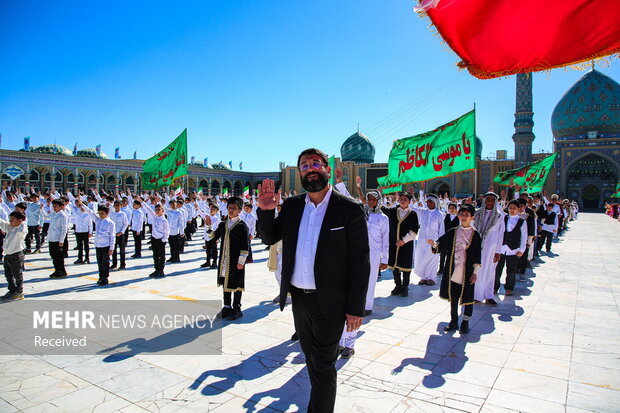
[257,190,370,317]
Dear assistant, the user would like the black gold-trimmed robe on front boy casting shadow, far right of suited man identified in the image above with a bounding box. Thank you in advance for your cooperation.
[431,227,482,305]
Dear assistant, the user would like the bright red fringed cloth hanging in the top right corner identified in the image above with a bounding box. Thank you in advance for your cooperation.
[421,0,620,79]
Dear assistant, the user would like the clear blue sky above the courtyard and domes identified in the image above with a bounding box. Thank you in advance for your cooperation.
[0,0,620,172]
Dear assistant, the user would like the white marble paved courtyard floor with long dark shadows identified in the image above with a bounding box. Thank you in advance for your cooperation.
[0,213,620,413]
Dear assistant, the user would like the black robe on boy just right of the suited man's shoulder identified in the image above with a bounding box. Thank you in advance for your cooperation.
[381,208,420,271]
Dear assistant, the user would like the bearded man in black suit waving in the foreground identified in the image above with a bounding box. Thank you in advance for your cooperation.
[257,148,370,413]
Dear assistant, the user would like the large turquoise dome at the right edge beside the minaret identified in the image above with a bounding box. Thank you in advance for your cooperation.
[551,69,620,138]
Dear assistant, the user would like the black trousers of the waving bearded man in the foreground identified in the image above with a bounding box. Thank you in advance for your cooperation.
[291,286,345,413]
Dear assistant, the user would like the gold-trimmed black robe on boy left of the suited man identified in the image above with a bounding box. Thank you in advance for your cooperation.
[211,218,250,292]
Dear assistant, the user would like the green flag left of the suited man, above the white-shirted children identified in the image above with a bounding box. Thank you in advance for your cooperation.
[142,129,187,189]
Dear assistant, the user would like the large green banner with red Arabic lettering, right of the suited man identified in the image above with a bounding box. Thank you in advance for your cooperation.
[388,109,476,184]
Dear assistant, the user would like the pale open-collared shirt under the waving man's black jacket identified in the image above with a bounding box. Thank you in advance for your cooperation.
[291,187,332,290]
